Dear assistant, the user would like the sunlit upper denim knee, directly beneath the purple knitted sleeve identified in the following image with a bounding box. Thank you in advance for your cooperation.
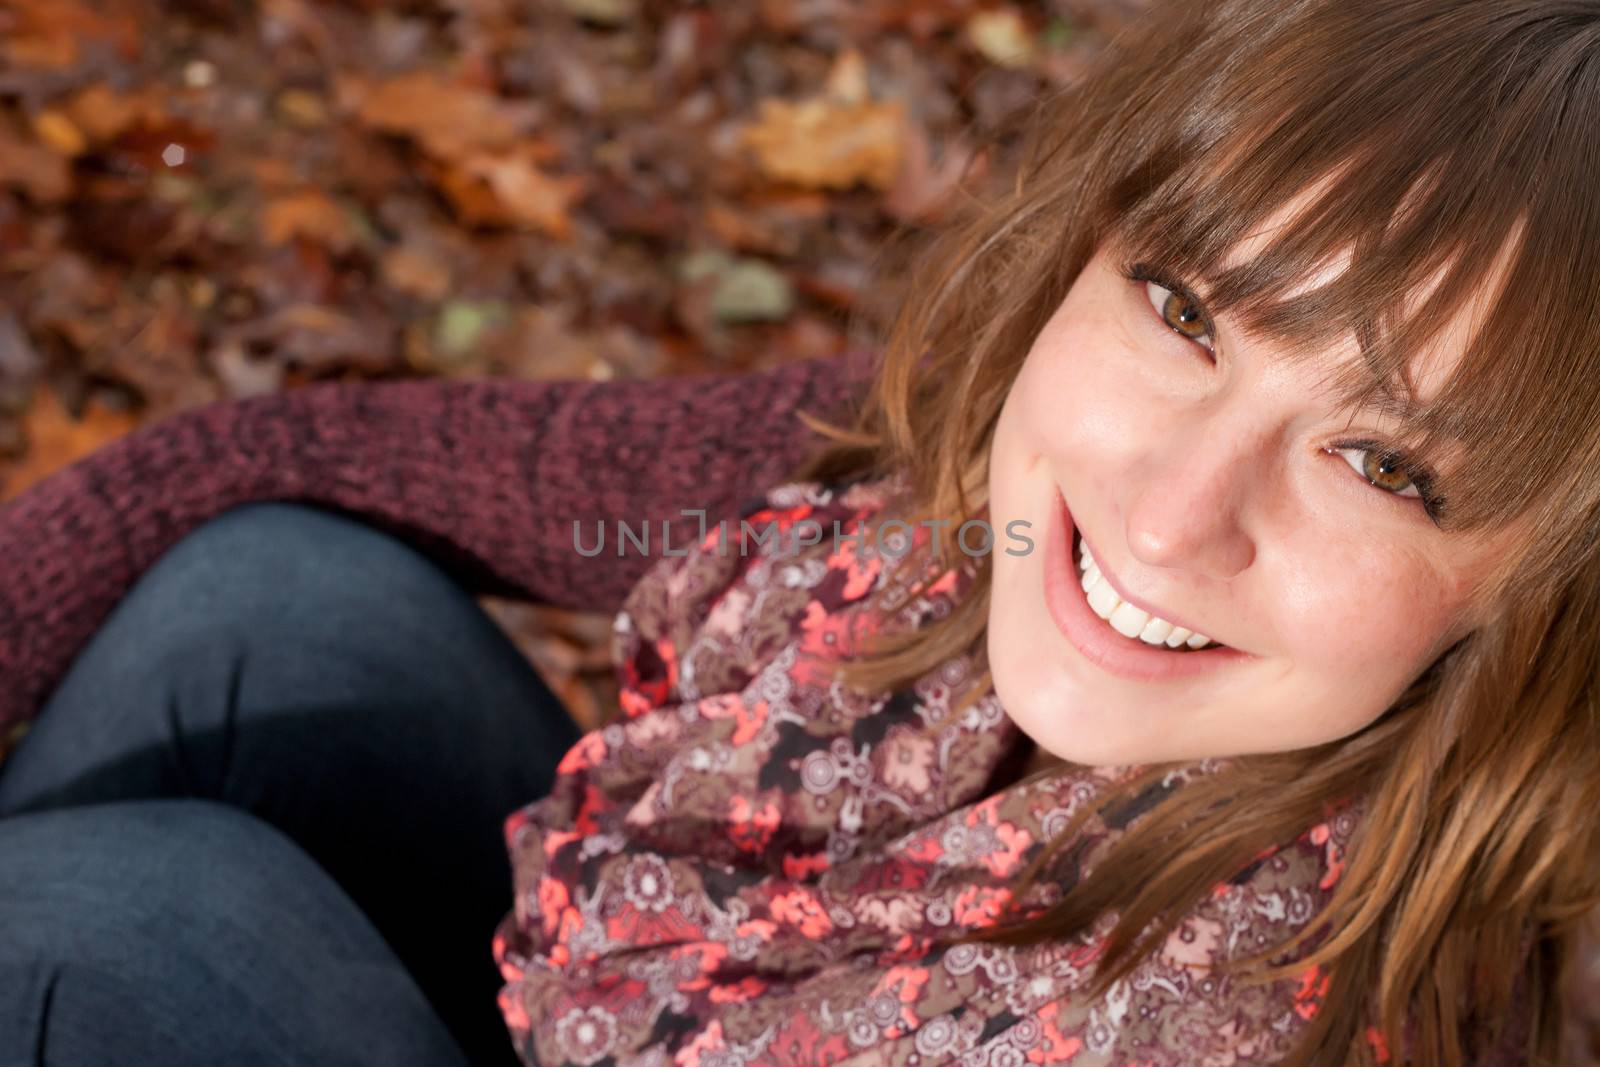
[0,502,578,797]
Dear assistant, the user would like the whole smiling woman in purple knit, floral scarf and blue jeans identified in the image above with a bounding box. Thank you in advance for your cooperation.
[0,0,1600,1067]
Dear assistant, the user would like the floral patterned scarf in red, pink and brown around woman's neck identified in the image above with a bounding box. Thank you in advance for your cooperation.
[494,480,1358,1067]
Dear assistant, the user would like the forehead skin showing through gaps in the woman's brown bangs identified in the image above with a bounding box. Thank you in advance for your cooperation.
[1219,176,1520,405]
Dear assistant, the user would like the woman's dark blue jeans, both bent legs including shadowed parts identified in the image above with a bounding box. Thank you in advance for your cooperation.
[0,502,579,1067]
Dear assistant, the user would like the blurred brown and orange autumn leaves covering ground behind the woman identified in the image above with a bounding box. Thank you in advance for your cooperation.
[0,0,1600,1064]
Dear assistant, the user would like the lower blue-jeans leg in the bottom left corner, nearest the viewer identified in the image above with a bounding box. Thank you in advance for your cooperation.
[0,800,464,1067]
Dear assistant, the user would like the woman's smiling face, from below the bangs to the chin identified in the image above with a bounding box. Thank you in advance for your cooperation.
[989,235,1512,765]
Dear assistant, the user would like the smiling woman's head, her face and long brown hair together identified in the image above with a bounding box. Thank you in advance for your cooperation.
[802,0,1600,1064]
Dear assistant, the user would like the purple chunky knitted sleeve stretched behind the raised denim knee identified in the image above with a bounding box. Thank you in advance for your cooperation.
[0,357,866,739]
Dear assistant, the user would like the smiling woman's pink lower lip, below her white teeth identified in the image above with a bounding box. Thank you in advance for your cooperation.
[1045,490,1251,681]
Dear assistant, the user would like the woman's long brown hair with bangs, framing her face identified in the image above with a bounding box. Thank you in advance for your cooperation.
[795,0,1600,1065]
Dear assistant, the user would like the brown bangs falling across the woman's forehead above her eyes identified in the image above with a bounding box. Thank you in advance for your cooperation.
[1098,3,1600,550]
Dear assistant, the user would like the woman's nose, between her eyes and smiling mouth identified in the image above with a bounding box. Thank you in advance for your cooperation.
[1123,418,1270,581]
